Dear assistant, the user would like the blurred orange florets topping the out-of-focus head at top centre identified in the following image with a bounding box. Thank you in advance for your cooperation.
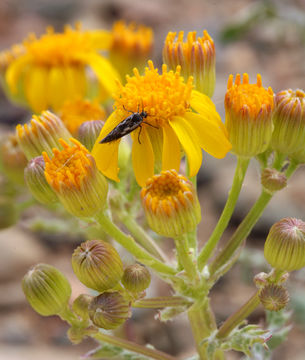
[111,21,153,57]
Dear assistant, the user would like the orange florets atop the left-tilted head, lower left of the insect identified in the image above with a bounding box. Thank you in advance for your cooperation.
[43,138,92,191]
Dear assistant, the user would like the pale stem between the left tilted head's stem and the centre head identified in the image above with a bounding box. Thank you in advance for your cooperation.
[117,211,169,263]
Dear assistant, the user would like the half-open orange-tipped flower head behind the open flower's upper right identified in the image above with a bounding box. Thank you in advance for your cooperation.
[163,30,215,97]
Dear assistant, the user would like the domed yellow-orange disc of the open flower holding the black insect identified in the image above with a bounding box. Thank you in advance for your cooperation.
[114,61,193,126]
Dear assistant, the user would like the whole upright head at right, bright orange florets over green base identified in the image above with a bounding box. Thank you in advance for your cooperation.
[225,74,273,157]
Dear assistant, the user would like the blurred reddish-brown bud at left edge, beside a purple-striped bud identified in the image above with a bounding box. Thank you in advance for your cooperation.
[0,135,28,184]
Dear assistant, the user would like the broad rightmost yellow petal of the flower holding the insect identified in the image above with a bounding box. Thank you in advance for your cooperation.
[185,112,232,159]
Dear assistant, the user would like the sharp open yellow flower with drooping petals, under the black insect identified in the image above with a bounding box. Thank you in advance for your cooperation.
[92,61,231,186]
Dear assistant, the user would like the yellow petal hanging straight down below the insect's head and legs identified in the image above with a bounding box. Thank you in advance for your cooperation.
[132,127,155,187]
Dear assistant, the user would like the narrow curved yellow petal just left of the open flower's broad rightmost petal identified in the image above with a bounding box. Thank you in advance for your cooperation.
[169,116,202,176]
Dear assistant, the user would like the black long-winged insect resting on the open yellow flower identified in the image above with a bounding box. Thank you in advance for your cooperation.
[100,108,158,144]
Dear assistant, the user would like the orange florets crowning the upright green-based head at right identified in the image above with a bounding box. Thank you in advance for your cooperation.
[225,74,273,118]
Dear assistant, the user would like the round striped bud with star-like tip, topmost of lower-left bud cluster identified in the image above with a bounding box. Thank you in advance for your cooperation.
[72,240,123,292]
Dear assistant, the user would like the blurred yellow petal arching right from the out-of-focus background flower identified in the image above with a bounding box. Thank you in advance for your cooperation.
[77,53,120,95]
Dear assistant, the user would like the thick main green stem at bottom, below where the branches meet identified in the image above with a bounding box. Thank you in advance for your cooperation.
[188,297,217,360]
